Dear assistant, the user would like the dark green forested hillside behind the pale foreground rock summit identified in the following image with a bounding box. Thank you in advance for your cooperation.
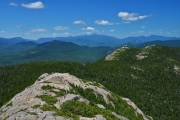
[0,46,180,120]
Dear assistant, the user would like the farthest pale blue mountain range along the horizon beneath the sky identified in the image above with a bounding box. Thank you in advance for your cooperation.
[0,34,180,47]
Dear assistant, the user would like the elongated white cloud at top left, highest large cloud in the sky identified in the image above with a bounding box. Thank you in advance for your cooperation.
[21,1,44,9]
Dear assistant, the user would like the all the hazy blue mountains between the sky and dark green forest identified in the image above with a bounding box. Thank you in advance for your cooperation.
[0,34,180,66]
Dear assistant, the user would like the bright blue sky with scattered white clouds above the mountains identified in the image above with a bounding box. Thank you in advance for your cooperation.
[0,0,180,39]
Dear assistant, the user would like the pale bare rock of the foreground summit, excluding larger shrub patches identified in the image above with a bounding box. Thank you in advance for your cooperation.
[0,73,152,120]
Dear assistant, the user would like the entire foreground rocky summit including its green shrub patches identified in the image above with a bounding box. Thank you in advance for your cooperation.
[0,73,152,120]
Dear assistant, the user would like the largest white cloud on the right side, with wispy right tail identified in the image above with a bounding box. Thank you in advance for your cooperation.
[118,12,148,21]
